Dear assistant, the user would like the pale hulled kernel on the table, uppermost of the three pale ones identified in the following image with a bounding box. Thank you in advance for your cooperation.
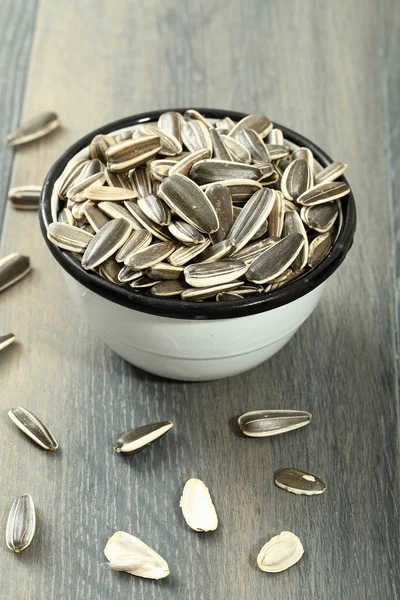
[180,479,218,531]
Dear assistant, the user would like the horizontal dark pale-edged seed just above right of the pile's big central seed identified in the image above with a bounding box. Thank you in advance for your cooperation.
[190,158,262,185]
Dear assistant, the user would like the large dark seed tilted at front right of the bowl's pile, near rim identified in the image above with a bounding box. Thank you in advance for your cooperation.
[246,233,304,283]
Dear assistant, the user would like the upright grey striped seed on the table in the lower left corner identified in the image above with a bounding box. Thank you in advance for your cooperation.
[6,494,36,554]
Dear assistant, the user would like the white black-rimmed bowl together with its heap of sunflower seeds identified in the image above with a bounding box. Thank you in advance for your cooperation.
[40,109,356,381]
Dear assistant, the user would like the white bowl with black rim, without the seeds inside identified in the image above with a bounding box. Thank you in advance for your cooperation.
[40,109,356,381]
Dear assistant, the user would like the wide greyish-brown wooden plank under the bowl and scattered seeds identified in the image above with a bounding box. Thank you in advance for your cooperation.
[0,0,400,600]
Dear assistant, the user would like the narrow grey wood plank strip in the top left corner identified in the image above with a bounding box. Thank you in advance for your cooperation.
[0,0,37,235]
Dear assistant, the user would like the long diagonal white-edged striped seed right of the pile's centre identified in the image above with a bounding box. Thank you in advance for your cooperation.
[227,188,275,251]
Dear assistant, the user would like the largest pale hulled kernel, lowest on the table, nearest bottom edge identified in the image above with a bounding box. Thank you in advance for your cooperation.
[104,531,170,579]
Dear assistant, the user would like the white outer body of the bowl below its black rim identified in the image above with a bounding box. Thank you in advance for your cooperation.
[63,271,325,381]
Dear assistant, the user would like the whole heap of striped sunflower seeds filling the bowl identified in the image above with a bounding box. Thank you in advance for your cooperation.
[48,110,350,302]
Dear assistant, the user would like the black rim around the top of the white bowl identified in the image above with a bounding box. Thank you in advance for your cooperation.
[39,108,356,319]
